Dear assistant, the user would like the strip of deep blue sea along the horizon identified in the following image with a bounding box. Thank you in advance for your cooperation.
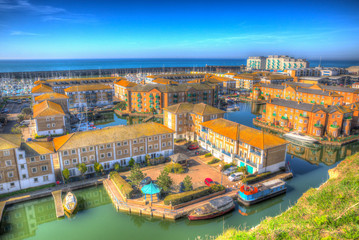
[0,58,359,72]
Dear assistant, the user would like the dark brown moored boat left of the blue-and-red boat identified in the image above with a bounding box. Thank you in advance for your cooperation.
[188,196,235,221]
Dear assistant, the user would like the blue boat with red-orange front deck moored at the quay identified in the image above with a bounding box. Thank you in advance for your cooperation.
[238,179,287,206]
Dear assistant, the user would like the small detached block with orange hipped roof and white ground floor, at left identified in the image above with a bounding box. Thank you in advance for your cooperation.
[32,100,66,136]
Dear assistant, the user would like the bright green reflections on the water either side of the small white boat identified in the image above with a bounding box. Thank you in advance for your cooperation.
[0,186,111,240]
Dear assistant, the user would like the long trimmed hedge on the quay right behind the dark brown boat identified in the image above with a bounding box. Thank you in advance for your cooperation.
[164,186,212,206]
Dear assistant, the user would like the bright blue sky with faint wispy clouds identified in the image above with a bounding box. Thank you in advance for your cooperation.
[0,0,359,60]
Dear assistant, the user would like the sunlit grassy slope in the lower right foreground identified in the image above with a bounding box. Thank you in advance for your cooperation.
[217,154,359,240]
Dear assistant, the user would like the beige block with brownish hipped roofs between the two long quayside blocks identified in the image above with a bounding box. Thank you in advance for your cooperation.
[163,103,225,140]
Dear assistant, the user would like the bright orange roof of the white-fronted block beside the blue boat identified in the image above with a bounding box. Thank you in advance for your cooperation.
[201,118,288,149]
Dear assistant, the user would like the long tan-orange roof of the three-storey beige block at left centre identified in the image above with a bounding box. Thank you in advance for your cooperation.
[54,122,174,151]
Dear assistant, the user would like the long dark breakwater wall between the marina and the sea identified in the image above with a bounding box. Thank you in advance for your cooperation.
[0,65,245,79]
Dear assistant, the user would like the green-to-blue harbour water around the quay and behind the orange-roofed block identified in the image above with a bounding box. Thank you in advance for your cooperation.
[0,104,359,240]
